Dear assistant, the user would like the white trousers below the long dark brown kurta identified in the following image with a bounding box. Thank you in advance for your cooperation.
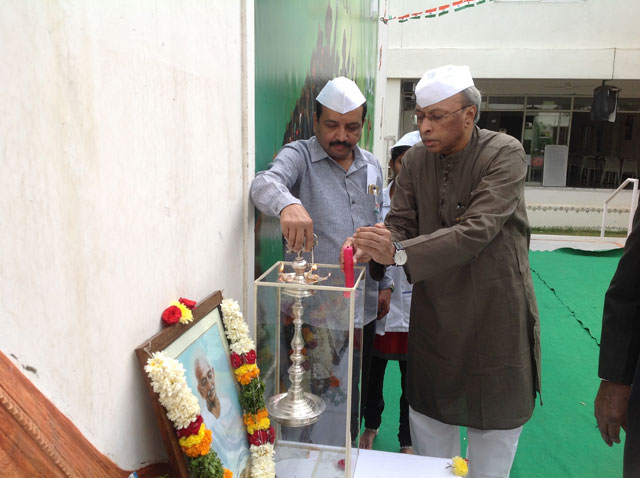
[409,407,522,478]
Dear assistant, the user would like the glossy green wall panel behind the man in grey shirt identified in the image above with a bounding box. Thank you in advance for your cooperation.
[255,0,378,274]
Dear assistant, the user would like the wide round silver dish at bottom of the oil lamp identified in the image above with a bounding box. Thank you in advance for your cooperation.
[267,392,326,427]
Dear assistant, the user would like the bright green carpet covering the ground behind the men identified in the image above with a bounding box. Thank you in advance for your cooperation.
[374,249,623,478]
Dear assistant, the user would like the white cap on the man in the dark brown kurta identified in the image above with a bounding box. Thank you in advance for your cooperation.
[416,65,474,108]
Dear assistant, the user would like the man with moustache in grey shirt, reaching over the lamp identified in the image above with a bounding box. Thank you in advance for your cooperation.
[251,77,391,442]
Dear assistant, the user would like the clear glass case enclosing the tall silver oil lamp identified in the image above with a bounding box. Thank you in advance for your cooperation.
[254,261,365,478]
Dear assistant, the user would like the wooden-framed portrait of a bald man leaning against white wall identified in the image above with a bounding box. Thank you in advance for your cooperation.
[136,291,251,478]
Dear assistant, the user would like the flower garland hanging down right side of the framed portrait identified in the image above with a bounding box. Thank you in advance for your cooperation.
[221,299,276,478]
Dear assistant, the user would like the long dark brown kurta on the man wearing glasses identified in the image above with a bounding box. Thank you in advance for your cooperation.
[385,127,540,430]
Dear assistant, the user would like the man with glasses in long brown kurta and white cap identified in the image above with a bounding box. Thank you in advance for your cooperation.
[353,66,540,478]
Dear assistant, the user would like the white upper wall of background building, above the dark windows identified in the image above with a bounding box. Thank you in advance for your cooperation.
[387,0,640,80]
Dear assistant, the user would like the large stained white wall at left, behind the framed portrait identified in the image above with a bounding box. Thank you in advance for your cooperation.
[0,0,254,469]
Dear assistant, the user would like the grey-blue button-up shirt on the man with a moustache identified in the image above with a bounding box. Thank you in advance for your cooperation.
[251,136,391,324]
